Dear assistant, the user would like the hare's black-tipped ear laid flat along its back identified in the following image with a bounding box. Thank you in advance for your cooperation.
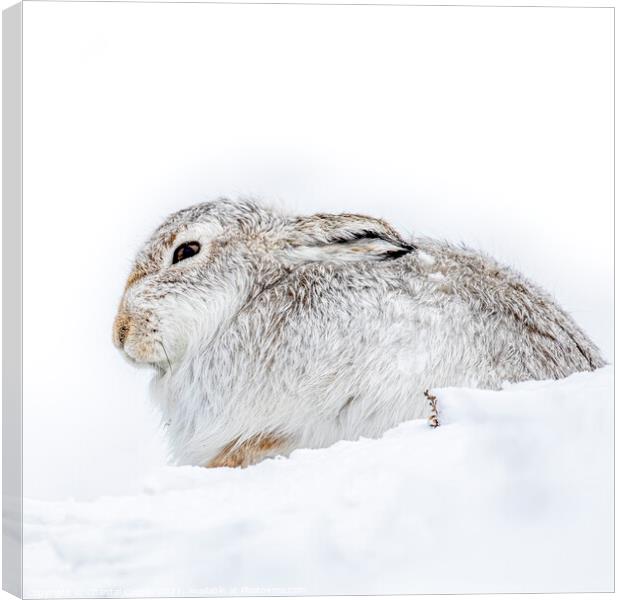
[285,214,415,262]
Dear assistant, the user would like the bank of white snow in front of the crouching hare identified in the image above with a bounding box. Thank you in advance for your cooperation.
[24,367,613,598]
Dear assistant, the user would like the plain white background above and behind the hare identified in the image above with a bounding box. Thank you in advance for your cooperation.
[17,2,613,506]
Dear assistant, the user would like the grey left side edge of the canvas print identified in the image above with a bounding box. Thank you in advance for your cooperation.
[2,2,23,597]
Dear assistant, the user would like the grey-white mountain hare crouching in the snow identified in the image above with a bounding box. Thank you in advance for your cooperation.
[114,200,604,467]
